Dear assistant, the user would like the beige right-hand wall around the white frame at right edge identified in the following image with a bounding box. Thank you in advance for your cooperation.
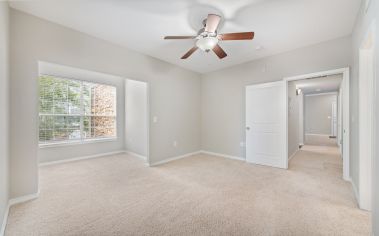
[350,0,379,235]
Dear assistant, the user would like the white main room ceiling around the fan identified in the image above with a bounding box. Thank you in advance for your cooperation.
[10,0,361,73]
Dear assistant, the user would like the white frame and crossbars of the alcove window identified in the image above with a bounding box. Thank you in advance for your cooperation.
[38,73,118,148]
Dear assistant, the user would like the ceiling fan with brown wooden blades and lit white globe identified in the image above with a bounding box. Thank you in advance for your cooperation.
[164,14,254,59]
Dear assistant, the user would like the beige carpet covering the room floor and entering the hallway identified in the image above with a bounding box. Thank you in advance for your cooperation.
[6,146,369,236]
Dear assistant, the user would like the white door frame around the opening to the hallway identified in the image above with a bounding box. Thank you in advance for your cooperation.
[283,67,350,181]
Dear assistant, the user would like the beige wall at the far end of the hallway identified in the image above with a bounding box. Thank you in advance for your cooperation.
[304,94,337,135]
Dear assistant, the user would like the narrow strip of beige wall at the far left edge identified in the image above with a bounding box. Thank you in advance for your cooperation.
[0,1,9,232]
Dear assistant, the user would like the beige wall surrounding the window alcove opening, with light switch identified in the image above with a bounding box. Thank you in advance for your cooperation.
[10,10,201,197]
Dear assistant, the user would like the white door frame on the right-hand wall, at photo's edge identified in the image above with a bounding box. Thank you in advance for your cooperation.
[358,20,377,210]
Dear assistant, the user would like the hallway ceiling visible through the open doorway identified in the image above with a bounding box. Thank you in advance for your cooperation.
[294,74,343,94]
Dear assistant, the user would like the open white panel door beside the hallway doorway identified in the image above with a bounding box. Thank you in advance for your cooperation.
[246,81,288,169]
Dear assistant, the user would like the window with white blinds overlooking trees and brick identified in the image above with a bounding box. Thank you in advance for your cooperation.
[39,75,116,145]
